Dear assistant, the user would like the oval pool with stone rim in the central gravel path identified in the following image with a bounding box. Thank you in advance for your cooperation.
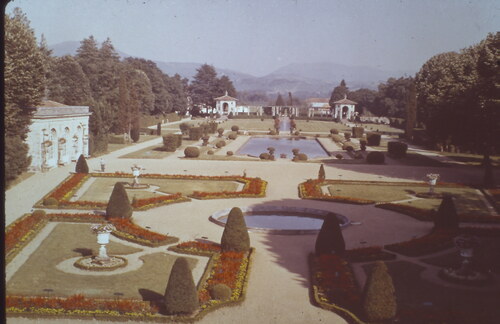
[209,206,350,235]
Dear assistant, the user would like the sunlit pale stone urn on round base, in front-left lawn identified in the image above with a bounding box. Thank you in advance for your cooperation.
[74,223,127,271]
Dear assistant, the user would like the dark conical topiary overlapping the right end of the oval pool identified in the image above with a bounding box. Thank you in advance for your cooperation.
[315,213,345,254]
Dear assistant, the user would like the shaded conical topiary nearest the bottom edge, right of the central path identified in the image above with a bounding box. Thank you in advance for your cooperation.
[363,261,397,321]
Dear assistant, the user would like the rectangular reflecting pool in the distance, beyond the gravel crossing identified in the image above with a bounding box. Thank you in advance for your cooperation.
[236,137,329,159]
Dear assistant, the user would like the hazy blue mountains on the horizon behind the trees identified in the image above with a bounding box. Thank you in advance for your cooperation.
[50,41,415,98]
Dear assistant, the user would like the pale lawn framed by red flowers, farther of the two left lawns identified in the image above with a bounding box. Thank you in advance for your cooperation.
[78,177,240,202]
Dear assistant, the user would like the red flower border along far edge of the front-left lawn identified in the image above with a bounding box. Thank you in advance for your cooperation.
[5,213,178,263]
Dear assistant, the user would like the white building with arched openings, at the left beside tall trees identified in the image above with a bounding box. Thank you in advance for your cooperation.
[26,101,92,171]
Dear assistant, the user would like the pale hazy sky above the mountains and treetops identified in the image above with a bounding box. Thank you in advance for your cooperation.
[6,0,500,76]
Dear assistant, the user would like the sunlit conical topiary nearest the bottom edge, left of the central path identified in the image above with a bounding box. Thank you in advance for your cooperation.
[163,257,200,315]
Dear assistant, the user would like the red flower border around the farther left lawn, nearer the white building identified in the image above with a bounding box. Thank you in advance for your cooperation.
[35,172,267,210]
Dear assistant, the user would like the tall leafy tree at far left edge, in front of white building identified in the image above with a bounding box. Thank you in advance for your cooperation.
[4,8,45,182]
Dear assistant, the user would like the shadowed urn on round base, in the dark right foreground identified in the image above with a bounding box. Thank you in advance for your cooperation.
[439,235,490,285]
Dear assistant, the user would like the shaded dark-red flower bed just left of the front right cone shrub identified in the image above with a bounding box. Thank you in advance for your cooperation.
[309,254,363,323]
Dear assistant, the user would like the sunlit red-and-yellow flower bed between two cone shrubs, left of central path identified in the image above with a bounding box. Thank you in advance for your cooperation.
[169,242,253,319]
